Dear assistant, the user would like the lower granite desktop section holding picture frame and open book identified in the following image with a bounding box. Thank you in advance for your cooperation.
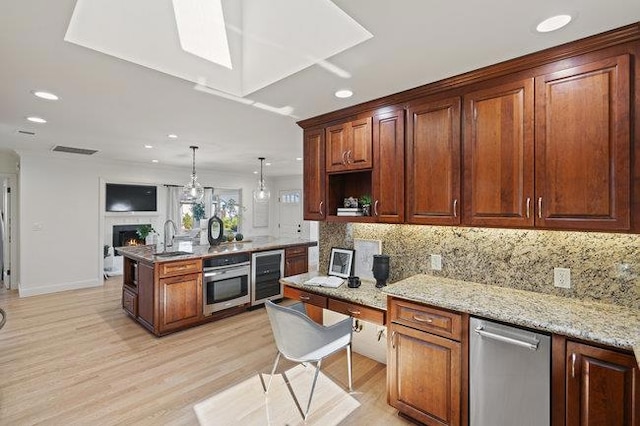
[280,272,387,311]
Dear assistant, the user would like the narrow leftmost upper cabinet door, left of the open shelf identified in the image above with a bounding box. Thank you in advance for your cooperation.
[302,129,327,220]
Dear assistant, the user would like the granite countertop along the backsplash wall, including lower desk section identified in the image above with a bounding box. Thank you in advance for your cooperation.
[282,272,640,364]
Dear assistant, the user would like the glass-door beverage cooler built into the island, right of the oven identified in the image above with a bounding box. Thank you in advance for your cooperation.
[251,250,284,306]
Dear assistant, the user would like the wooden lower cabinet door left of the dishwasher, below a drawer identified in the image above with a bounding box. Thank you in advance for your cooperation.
[387,324,461,425]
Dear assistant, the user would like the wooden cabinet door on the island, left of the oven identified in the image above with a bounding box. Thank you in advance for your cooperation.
[158,274,202,333]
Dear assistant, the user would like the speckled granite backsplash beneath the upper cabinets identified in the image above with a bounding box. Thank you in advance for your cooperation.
[319,222,640,308]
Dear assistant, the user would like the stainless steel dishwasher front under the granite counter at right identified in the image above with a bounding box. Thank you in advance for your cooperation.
[469,317,551,426]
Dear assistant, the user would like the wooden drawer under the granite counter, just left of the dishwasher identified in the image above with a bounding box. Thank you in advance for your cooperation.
[389,299,462,341]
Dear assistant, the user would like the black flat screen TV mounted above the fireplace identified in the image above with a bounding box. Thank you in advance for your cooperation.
[106,183,158,212]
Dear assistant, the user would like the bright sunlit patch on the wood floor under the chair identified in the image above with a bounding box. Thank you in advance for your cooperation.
[193,365,360,426]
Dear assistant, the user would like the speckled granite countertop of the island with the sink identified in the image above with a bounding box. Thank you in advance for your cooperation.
[115,237,318,263]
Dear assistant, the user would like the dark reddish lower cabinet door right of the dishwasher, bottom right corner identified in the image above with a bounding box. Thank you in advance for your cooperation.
[566,341,640,426]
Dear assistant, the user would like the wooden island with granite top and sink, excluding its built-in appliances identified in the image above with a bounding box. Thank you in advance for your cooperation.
[116,237,317,336]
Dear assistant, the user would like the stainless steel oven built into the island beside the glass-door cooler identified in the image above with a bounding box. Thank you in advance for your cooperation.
[202,253,251,315]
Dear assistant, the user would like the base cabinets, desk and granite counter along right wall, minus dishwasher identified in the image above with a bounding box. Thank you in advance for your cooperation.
[282,272,640,425]
